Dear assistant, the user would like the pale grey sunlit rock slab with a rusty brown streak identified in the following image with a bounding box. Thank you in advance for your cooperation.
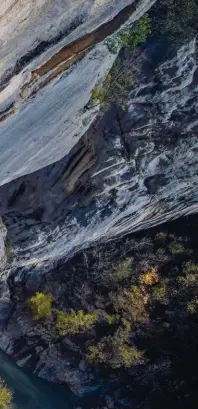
[0,0,154,184]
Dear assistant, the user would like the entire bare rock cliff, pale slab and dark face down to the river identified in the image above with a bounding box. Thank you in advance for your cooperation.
[0,0,198,398]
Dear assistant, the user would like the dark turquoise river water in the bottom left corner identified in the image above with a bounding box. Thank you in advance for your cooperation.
[0,351,79,409]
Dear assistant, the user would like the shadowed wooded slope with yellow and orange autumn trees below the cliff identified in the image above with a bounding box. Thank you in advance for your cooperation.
[23,216,198,409]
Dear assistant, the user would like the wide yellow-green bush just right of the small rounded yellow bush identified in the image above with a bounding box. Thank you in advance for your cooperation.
[56,310,98,335]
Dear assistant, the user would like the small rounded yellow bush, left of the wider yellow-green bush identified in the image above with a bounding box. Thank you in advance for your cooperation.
[28,291,53,320]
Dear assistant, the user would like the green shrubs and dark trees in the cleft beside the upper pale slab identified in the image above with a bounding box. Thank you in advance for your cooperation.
[88,0,198,115]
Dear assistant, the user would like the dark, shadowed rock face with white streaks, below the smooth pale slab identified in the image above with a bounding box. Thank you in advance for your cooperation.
[0,37,198,271]
